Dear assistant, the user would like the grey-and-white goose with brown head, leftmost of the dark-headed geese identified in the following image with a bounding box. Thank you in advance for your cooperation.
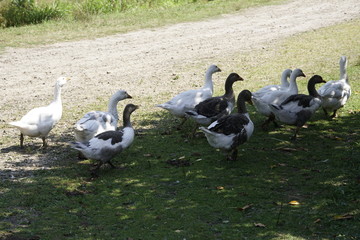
[70,104,138,173]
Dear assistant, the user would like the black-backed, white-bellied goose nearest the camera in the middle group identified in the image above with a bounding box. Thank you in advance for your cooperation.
[200,90,254,160]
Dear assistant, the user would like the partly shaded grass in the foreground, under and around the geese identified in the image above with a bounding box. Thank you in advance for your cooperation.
[0,4,360,240]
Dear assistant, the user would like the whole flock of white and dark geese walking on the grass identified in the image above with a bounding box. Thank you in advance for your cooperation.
[9,56,351,175]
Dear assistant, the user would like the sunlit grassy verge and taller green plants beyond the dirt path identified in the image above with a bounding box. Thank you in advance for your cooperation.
[0,0,283,52]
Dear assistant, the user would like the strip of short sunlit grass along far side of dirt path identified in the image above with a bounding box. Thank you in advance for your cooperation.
[0,0,283,52]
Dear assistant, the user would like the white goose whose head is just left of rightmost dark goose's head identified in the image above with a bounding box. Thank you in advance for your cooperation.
[252,68,306,130]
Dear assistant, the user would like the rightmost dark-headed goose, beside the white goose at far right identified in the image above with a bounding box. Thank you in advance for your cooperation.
[269,75,326,140]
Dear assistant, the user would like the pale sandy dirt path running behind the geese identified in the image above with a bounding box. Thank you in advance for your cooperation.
[0,0,360,177]
